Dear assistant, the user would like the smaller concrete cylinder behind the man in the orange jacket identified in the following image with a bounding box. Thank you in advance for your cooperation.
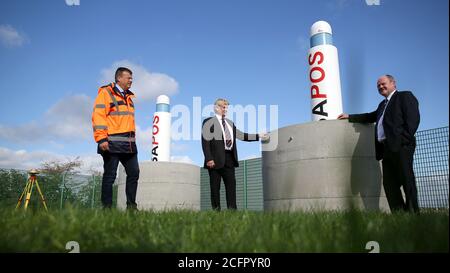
[116,161,200,210]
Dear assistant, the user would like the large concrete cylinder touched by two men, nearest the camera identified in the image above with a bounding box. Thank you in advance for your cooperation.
[262,120,389,211]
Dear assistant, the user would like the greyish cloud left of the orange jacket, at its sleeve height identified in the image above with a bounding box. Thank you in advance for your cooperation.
[0,94,94,143]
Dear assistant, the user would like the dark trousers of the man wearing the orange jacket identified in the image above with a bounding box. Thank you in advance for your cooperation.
[101,152,139,207]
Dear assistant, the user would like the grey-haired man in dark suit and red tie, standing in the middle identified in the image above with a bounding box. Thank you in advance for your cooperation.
[202,99,268,211]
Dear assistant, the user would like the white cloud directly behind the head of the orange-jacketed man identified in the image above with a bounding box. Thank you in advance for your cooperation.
[100,60,178,102]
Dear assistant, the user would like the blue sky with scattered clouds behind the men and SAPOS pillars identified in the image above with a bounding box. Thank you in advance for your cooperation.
[0,0,449,172]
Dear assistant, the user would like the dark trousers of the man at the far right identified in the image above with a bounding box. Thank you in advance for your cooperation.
[382,142,419,213]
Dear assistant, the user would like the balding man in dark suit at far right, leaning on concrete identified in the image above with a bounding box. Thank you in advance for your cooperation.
[338,75,420,213]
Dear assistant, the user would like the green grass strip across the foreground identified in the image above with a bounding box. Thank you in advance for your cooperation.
[0,207,449,253]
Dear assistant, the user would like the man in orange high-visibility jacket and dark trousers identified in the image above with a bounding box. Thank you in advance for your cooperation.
[92,67,139,210]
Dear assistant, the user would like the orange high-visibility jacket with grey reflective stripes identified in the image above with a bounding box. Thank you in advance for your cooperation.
[92,83,136,153]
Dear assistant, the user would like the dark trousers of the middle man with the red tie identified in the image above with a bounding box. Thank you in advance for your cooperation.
[208,151,237,211]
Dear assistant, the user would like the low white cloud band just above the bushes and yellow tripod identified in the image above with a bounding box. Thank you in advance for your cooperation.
[0,147,103,174]
